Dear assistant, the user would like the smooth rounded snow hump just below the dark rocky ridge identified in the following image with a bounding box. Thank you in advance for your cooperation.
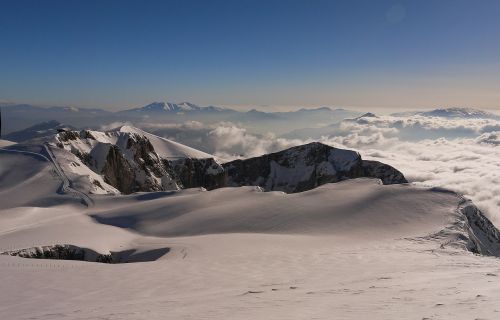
[92,179,457,239]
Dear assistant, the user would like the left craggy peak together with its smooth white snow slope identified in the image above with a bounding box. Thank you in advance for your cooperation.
[55,126,224,193]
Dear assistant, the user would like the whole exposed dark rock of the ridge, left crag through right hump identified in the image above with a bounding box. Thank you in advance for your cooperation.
[56,131,407,194]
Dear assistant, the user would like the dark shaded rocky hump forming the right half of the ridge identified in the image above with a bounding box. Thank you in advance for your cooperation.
[223,142,407,193]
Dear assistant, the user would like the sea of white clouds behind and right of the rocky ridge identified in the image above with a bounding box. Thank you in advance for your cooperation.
[132,116,500,226]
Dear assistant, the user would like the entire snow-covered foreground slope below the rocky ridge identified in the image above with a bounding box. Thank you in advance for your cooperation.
[0,135,500,319]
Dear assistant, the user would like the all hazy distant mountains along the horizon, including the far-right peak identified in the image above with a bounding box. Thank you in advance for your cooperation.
[0,102,500,141]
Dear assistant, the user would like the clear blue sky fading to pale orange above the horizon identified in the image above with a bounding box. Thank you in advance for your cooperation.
[0,0,500,109]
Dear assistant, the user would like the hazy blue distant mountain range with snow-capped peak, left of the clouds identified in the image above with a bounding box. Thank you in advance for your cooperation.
[0,102,361,134]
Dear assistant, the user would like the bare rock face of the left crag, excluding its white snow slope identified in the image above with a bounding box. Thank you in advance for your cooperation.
[56,131,225,194]
